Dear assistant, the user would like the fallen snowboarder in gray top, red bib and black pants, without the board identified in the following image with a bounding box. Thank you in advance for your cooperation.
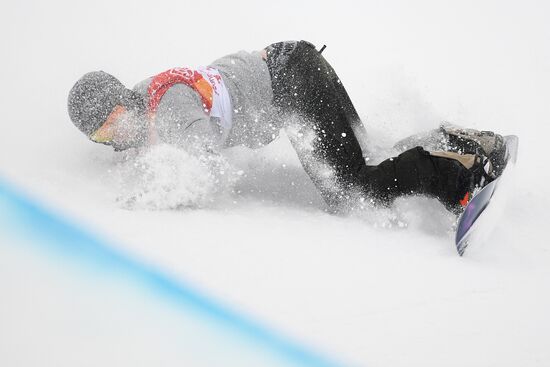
[68,41,505,213]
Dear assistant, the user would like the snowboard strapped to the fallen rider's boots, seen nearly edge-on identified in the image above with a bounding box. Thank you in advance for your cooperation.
[455,135,519,256]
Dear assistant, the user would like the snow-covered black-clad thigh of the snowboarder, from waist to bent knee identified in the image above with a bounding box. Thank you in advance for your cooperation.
[267,41,365,208]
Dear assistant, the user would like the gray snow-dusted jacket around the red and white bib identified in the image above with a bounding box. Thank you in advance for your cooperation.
[134,51,282,150]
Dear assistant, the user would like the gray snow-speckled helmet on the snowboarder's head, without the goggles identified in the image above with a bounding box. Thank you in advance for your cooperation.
[68,71,144,136]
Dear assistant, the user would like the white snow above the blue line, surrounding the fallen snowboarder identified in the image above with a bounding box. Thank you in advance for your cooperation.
[0,0,550,366]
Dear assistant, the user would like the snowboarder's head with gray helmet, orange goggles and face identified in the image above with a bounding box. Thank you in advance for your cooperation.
[68,71,145,150]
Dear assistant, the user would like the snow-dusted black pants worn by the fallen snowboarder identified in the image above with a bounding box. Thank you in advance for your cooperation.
[266,41,472,210]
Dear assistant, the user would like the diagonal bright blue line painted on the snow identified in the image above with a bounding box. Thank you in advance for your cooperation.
[0,180,341,367]
